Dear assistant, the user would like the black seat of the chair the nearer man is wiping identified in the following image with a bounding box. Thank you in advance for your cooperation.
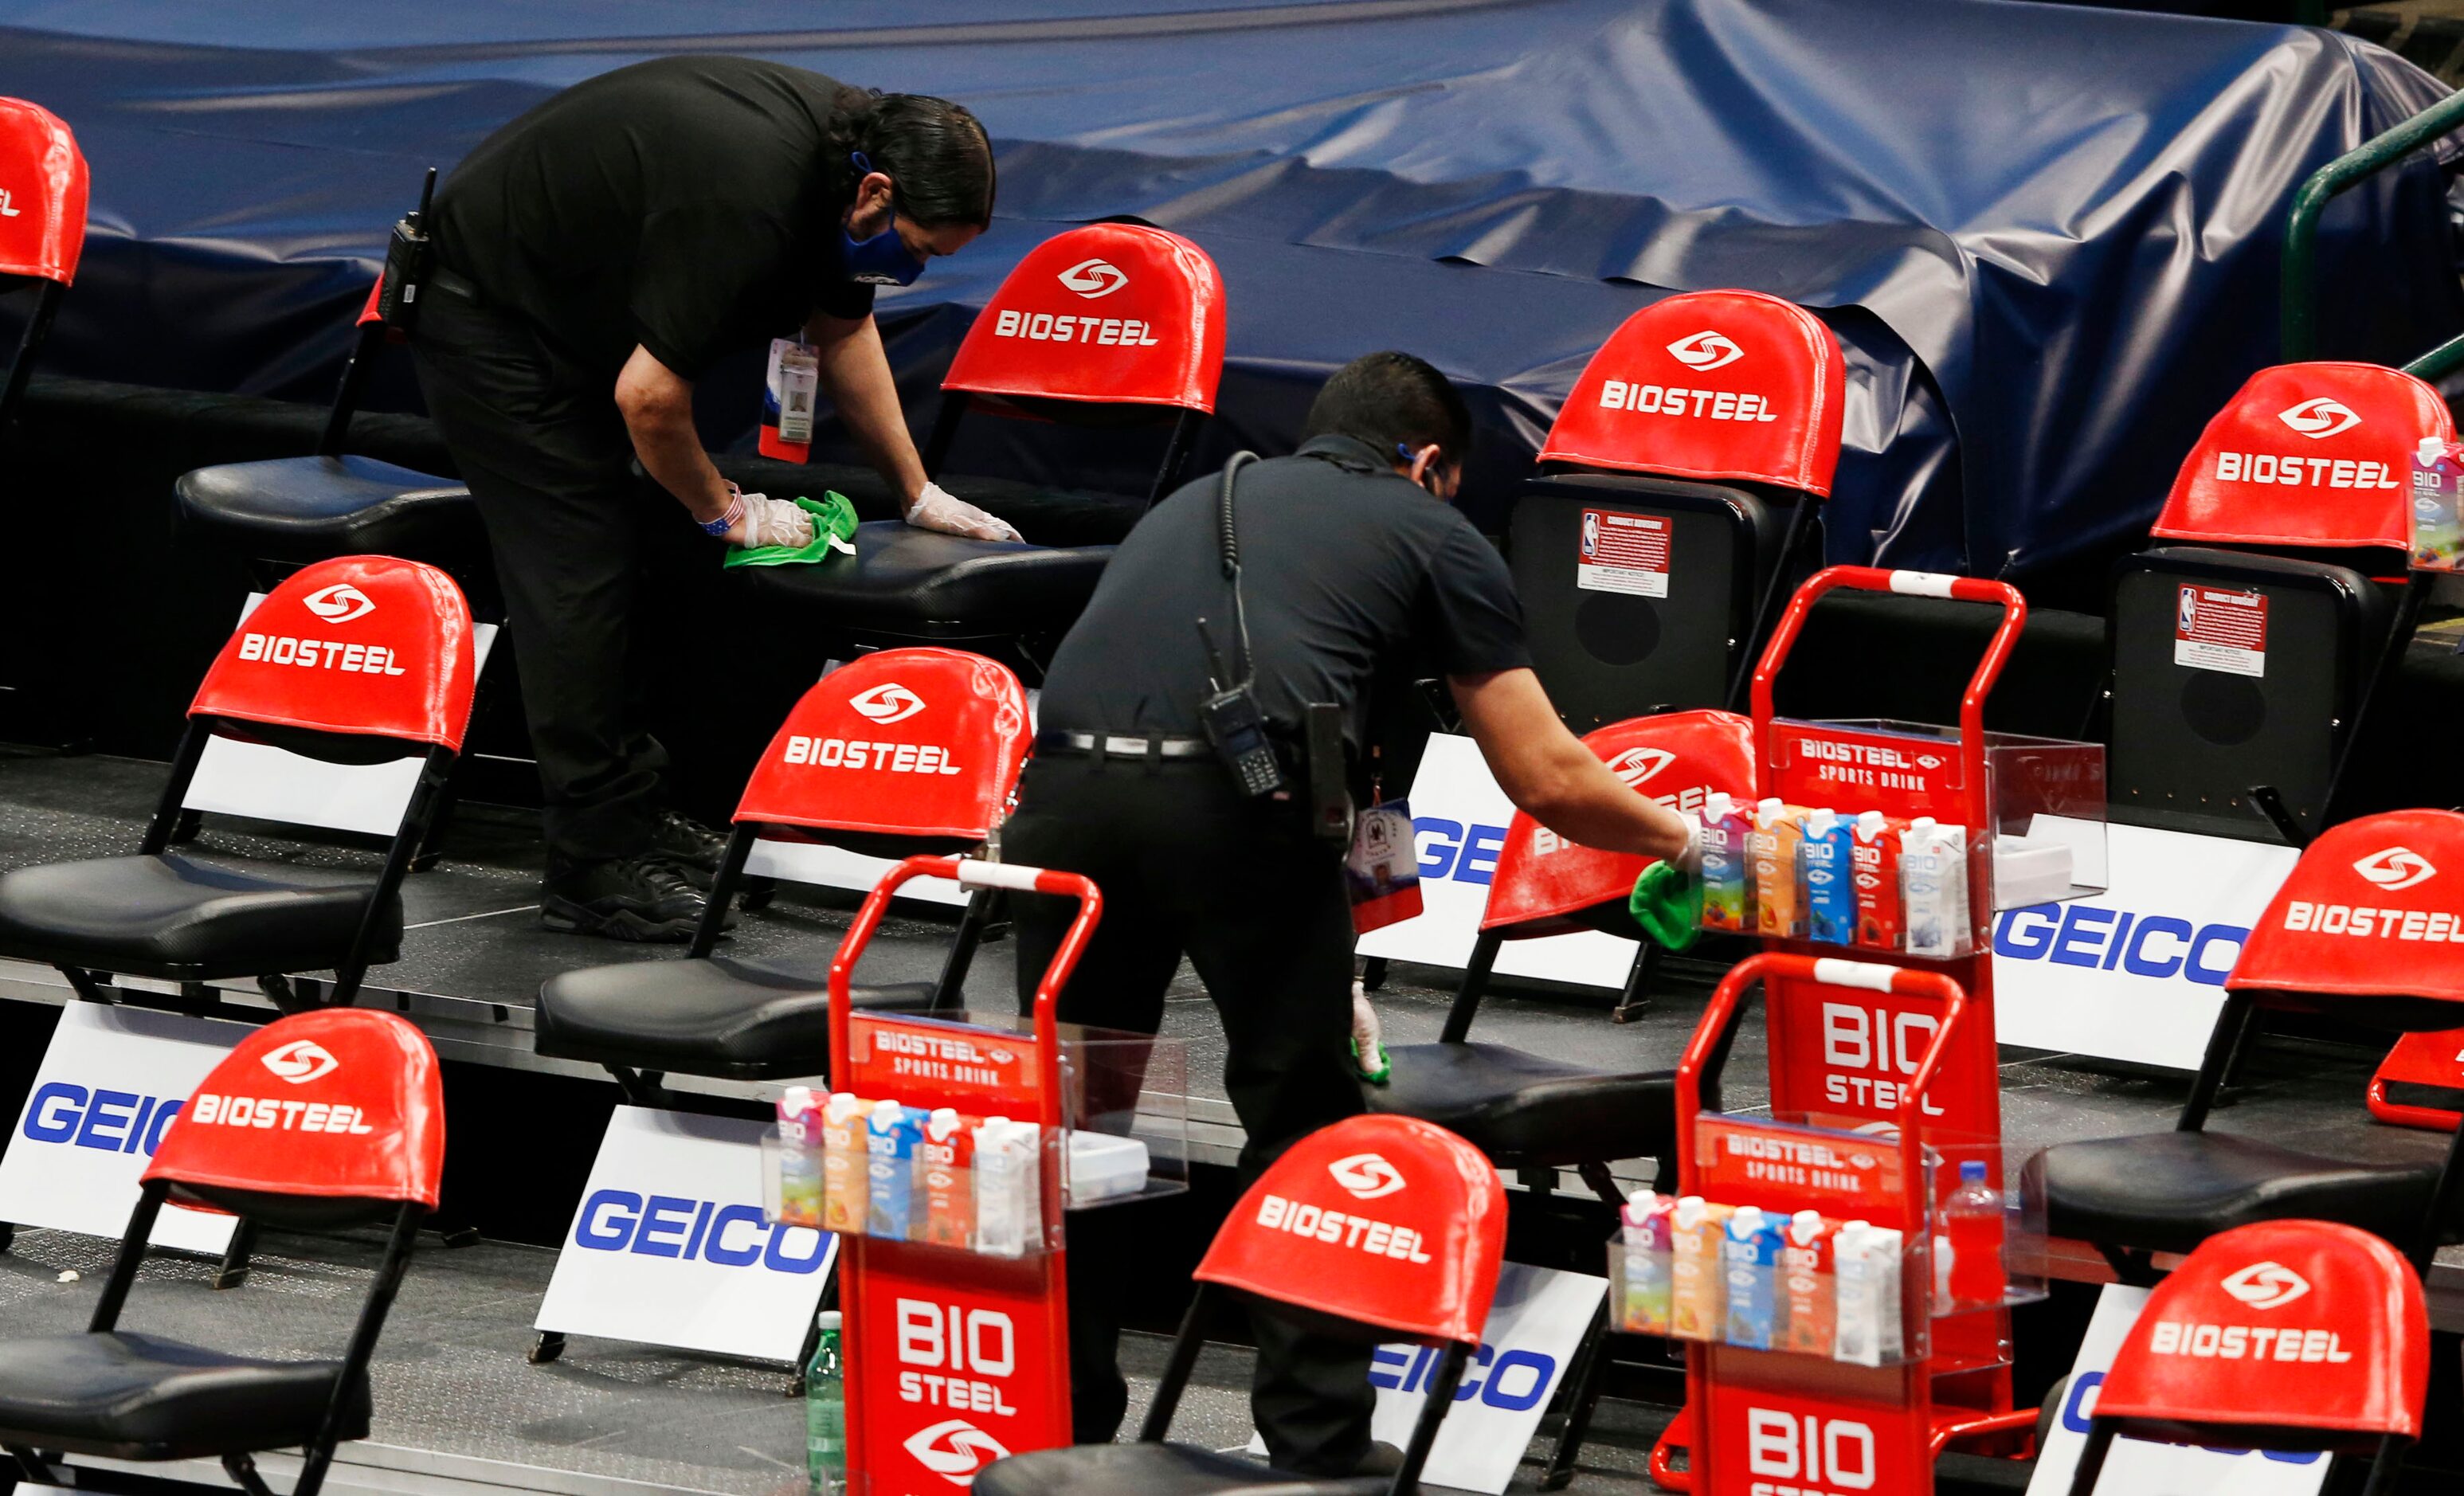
[1360,1045,1678,1165]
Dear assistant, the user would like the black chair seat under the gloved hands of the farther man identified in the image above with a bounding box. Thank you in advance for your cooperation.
[737,520,1111,638]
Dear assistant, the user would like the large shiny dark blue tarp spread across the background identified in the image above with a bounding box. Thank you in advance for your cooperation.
[0,0,2464,579]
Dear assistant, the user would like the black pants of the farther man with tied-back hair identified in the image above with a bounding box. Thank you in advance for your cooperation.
[412,288,695,867]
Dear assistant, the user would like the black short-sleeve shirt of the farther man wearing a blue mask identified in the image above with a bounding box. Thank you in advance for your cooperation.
[436,57,872,382]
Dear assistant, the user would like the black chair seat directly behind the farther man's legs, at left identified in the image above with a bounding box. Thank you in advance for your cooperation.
[175,456,480,562]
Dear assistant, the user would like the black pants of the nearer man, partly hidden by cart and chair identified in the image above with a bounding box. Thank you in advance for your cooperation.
[1001,757,1375,1474]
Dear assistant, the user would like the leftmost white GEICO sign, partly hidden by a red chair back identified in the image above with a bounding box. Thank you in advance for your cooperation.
[0,1003,251,1252]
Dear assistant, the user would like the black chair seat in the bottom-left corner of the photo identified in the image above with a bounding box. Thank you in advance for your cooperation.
[0,1333,367,1459]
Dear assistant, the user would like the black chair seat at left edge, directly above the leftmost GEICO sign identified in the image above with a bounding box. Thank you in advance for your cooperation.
[0,852,402,981]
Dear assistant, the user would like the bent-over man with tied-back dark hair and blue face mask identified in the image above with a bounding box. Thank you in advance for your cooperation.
[414,57,1015,939]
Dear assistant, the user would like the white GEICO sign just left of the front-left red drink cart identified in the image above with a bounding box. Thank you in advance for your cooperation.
[535,1106,838,1361]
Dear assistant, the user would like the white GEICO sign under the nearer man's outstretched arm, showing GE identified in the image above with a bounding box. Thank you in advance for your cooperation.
[1357,732,1634,989]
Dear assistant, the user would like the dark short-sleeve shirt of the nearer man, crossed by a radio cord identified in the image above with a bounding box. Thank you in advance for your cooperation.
[1037,437,1530,746]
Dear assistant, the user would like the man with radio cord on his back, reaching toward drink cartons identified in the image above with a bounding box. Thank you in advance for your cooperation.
[1003,352,1693,1476]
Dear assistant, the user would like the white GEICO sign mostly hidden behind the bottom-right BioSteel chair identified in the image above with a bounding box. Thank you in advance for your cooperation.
[2028,1284,2329,1496]
